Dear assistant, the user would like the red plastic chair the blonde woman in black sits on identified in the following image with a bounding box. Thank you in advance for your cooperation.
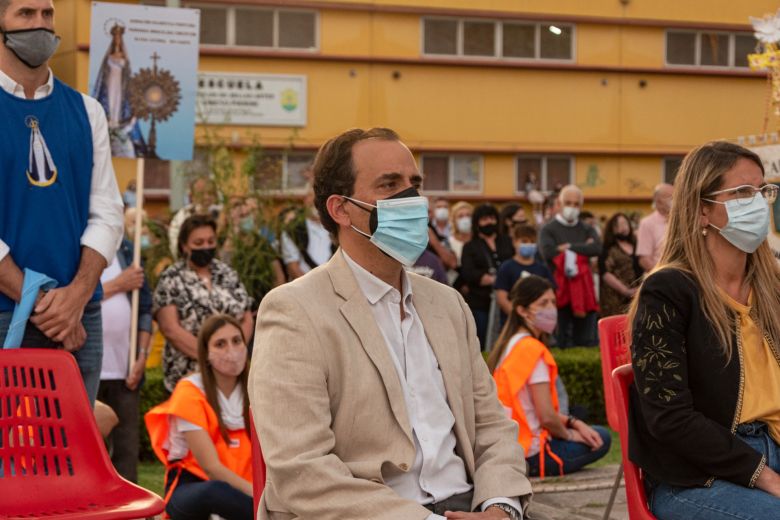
[612,365,655,520]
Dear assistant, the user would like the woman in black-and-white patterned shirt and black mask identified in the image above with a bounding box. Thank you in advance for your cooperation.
[153,215,254,392]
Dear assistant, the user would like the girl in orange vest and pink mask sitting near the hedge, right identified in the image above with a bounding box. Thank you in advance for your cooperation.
[488,275,611,477]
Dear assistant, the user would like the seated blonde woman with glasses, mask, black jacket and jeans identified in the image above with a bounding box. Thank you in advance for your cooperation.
[629,142,780,520]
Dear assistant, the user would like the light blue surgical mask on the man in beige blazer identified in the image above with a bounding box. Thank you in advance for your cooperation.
[344,188,428,266]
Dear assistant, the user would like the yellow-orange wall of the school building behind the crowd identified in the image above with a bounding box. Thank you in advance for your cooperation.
[52,0,777,217]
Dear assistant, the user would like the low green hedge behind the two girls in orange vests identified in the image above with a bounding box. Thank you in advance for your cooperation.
[140,347,607,460]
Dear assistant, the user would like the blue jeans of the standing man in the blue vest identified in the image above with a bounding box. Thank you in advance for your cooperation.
[0,302,103,405]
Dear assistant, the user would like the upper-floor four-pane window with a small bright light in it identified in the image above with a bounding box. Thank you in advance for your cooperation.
[422,18,574,60]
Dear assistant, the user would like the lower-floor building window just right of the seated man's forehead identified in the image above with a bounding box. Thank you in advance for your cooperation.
[422,154,482,193]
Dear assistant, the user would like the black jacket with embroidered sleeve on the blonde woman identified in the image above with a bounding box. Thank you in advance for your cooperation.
[628,269,764,487]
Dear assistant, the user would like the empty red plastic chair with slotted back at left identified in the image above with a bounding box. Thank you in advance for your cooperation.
[0,349,165,520]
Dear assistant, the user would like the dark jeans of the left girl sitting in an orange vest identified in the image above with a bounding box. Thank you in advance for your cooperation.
[165,470,255,520]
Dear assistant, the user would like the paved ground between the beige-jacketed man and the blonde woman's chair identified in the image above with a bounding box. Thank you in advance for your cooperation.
[531,465,628,520]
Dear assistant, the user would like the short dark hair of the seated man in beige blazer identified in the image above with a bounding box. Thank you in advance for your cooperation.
[310,128,401,236]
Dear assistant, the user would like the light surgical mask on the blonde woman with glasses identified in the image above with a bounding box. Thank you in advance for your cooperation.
[703,195,769,253]
